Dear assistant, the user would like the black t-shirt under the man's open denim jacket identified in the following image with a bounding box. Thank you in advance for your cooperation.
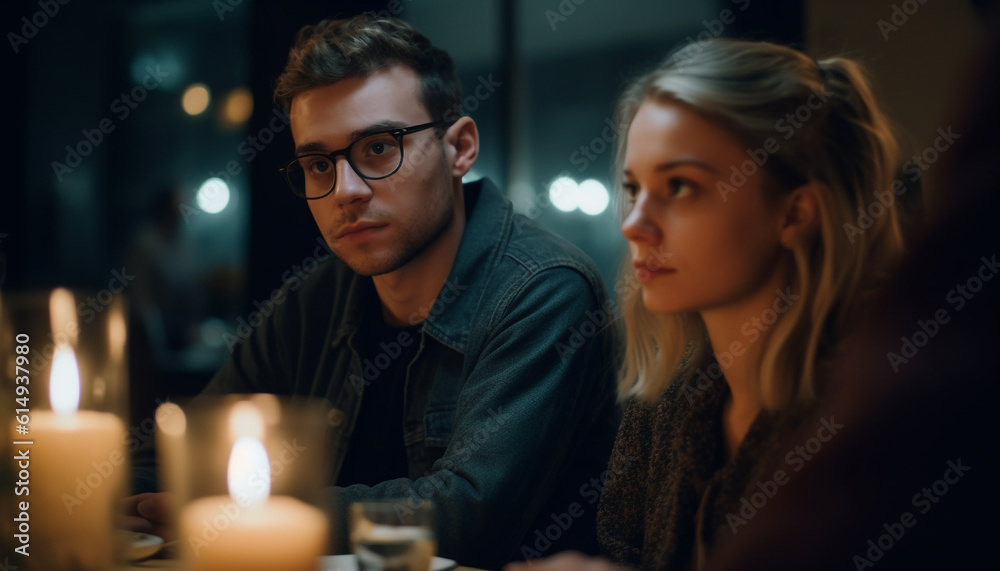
[337,308,421,486]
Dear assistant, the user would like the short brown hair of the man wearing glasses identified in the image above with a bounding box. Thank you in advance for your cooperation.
[274,13,462,121]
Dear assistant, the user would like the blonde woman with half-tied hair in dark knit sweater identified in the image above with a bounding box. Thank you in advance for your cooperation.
[508,40,905,569]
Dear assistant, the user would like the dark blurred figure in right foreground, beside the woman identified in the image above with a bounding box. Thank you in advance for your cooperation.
[709,2,1000,571]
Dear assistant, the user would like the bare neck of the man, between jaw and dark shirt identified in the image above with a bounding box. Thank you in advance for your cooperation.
[373,181,466,327]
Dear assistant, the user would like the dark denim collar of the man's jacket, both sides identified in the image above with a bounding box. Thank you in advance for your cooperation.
[333,179,514,353]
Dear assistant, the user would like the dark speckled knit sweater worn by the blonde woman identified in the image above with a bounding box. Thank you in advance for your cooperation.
[597,368,819,570]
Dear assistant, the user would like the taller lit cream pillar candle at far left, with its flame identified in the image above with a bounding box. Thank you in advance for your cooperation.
[25,344,127,569]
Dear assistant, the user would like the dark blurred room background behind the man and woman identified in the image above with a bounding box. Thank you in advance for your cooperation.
[0,0,979,424]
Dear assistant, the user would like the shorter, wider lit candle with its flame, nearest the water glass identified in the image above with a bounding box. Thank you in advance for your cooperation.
[178,402,328,571]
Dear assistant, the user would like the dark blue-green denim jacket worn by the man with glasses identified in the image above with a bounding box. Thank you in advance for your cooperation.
[137,180,619,568]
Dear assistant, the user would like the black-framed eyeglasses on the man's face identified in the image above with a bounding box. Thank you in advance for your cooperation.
[280,120,449,200]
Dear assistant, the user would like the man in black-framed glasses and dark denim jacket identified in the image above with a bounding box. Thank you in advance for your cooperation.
[127,15,617,568]
